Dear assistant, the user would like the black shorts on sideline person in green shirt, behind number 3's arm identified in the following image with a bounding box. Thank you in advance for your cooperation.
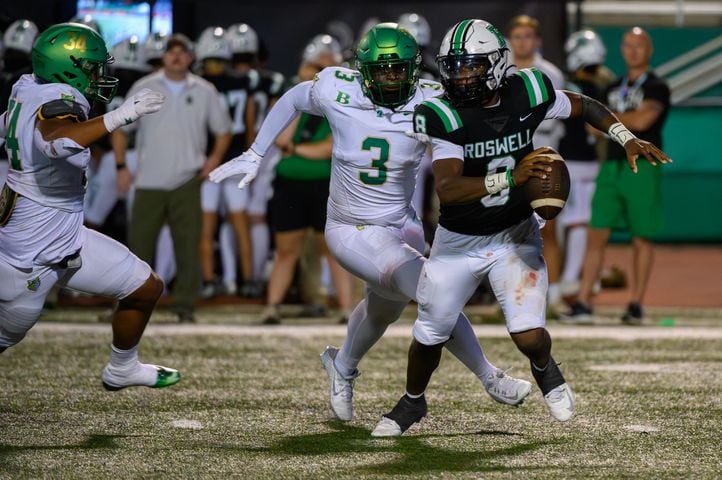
[269,177,329,232]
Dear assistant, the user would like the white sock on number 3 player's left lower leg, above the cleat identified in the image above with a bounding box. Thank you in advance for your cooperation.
[335,289,408,377]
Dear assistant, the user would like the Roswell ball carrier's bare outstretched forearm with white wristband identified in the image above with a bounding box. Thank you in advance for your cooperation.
[564,91,672,173]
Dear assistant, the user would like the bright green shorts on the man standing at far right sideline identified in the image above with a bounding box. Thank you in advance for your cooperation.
[589,158,663,238]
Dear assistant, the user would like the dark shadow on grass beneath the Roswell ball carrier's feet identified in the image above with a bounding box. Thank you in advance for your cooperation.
[252,421,547,475]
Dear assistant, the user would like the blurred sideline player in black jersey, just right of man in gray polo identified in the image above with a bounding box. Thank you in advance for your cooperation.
[196,27,258,298]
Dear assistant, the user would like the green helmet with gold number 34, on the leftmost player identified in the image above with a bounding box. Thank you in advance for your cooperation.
[32,23,118,103]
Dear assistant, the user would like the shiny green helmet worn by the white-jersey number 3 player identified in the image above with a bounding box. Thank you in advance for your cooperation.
[356,22,421,108]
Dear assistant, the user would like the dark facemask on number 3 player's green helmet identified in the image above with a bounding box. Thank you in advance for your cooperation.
[357,59,420,108]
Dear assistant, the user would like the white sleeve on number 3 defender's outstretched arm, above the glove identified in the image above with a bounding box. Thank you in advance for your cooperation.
[251,80,323,156]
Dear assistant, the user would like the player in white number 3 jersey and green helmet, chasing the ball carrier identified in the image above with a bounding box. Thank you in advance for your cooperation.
[210,23,531,420]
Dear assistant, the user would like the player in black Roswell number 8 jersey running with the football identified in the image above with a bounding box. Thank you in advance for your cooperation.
[372,20,669,436]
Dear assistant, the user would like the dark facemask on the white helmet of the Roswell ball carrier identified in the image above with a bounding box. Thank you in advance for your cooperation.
[437,50,502,106]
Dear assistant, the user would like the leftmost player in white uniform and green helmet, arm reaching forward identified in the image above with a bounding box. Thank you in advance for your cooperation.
[0,23,180,390]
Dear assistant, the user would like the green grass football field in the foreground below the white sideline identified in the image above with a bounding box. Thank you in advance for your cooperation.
[0,314,722,479]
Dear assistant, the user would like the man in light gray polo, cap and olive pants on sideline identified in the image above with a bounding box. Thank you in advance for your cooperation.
[113,34,231,322]
